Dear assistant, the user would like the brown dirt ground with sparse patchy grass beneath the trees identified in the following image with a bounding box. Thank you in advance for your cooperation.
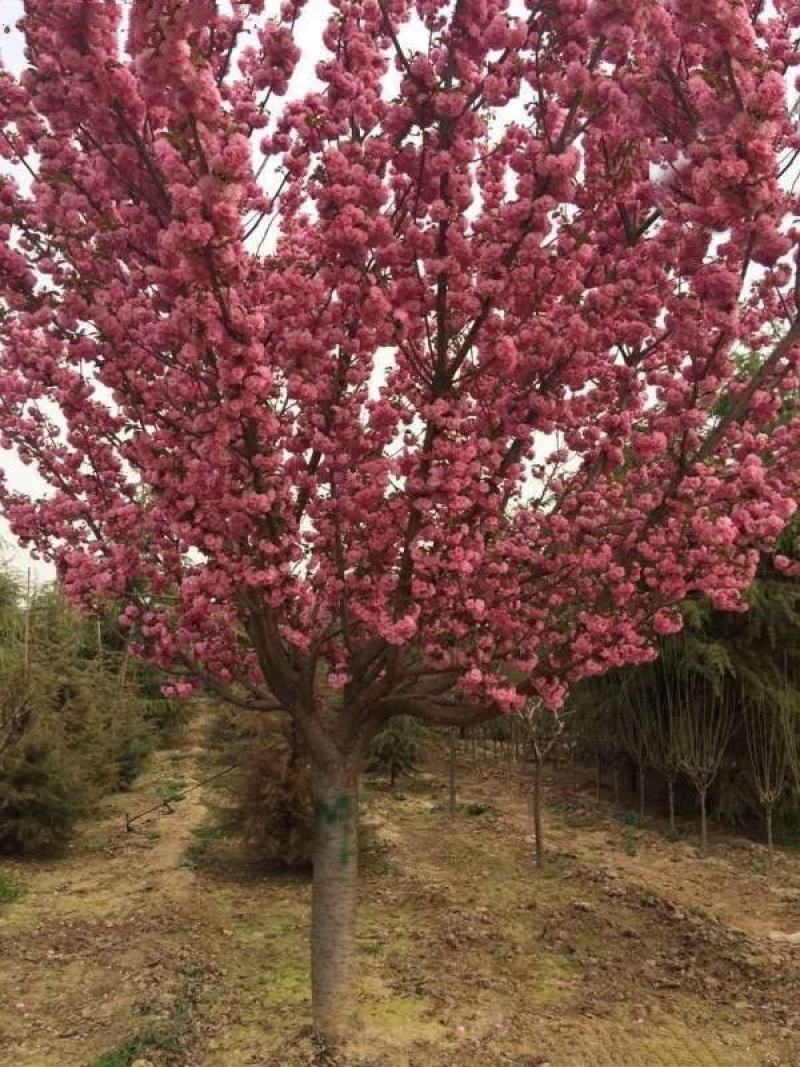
[0,722,800,1067]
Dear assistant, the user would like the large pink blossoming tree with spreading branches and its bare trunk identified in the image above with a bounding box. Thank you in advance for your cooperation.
[0,0,800,1038]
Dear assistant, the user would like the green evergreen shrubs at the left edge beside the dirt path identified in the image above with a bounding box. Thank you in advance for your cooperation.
[0,569,186,853]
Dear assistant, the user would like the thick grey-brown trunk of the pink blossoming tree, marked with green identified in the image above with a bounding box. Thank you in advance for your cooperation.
[311,758,359,1047]
